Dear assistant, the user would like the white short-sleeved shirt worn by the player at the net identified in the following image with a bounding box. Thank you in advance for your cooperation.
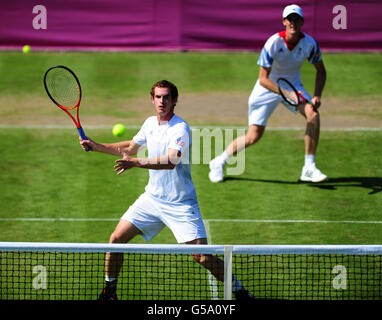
[133,114,197,205]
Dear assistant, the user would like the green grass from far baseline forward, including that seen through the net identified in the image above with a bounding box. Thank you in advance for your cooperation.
[0,128,382,300]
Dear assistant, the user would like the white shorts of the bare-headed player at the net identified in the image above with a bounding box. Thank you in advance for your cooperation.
[121,193,207,243]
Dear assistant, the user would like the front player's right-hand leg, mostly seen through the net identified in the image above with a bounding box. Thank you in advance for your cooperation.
[187,238,253,300]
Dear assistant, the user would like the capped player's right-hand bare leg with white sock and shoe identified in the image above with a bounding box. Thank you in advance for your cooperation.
[298,104,327,182]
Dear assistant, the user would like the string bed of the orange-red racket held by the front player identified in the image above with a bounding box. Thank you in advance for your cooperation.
[46,68,80,109]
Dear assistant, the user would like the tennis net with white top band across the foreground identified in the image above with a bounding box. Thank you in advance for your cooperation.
[0,242,382,300]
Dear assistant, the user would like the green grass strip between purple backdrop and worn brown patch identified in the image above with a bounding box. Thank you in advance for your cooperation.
[0,52,382,99]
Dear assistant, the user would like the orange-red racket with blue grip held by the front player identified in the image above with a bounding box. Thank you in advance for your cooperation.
[44,65,91,151]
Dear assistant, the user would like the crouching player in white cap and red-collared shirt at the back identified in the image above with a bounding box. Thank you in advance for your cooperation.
[209,5,327,182]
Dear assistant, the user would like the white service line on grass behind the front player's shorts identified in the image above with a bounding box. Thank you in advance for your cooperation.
[0,217,382,224]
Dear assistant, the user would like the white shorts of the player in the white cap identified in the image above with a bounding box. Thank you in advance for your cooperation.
[248,81,311,126]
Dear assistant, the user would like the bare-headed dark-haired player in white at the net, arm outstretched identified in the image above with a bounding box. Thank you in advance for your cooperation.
[80,80,253,300]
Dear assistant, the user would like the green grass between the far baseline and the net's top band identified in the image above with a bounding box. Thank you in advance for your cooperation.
[0,129,382,244]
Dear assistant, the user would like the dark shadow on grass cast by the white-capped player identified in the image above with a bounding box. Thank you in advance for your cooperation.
[224,176,382,195]
